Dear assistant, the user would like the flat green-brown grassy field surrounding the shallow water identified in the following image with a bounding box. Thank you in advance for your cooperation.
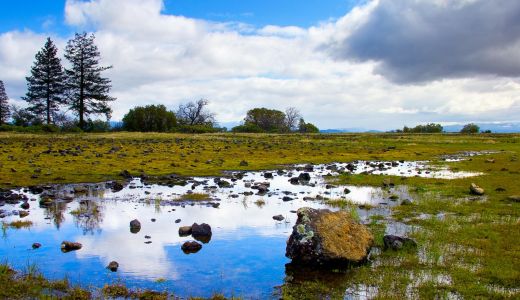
[0,133,520,299]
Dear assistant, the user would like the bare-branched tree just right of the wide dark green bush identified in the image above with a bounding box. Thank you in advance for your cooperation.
[177,99,215,126]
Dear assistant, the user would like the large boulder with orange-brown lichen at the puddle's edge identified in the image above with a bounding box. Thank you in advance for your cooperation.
[285,207,374,265]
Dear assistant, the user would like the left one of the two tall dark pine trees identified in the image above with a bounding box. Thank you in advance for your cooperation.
[23,38,65,124]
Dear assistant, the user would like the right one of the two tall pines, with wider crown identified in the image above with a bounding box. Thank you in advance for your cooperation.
[65,33,115,128]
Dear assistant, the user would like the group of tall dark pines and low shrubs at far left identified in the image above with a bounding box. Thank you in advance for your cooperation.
[0,32,116,130]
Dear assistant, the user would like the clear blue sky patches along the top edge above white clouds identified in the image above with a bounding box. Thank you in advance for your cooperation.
[0,0,360,34]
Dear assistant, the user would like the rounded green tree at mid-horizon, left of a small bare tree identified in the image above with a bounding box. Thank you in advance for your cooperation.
[244,108,287,132]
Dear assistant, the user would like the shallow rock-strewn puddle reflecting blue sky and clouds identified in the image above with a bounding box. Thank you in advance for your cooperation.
[0,161,480,299]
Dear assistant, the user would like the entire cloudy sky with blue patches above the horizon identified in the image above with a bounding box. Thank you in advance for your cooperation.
[0,0,520,130]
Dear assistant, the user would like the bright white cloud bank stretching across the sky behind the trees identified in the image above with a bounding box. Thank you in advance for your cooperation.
[0,0,520,129]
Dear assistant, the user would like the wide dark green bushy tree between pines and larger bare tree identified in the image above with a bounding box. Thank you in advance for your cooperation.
[123,105,177,132]
